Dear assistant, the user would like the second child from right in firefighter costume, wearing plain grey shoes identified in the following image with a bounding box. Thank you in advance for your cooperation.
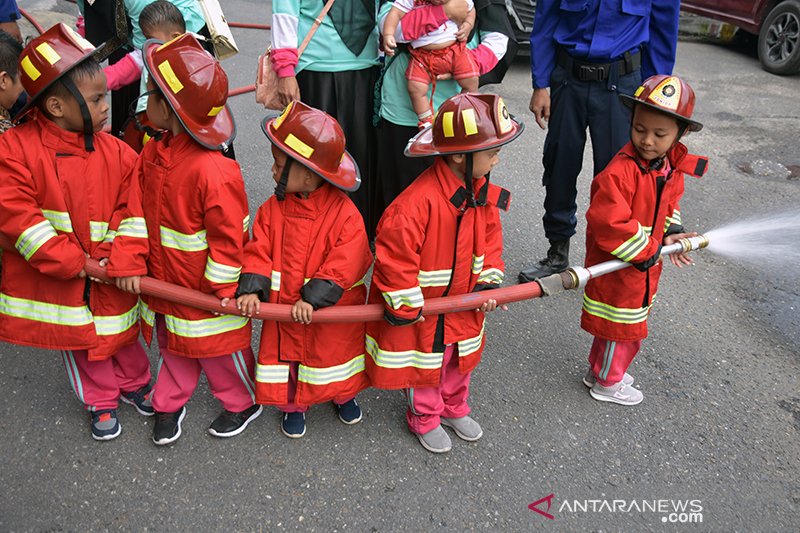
[367,93,523,453]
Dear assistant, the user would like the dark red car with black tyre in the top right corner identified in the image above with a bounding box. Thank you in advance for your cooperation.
[681,0,800,75]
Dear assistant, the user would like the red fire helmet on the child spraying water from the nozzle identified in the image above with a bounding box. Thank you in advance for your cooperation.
[620,74,703,131]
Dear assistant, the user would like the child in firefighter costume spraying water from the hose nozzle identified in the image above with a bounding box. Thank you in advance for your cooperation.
[581,75,708,405]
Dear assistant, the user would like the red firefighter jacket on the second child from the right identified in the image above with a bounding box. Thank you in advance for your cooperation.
[367,157,510,389]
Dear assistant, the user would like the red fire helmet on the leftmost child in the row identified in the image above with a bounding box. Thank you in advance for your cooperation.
[14,22,95,120]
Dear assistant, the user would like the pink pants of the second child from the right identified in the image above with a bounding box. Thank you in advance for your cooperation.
[405,344,472,435]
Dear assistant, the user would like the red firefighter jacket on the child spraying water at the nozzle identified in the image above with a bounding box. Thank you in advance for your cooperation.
[581,143,708,341]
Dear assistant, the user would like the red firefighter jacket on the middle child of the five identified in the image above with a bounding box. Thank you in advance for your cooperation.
[239,183,372,405]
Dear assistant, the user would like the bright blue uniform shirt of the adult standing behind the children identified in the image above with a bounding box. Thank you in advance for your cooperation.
[531,0,680,88]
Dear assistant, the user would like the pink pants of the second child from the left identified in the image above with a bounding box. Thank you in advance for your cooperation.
[152,315,255,413]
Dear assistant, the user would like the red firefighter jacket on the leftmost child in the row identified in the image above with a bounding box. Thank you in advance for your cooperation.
[0,113,139,360]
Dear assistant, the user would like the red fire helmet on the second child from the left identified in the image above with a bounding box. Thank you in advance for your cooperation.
[142,33,236,150]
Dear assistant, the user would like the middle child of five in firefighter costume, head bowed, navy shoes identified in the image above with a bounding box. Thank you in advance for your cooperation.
[237,102,372,438]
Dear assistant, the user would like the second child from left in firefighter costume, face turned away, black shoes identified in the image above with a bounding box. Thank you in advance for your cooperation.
[108,34,261,445]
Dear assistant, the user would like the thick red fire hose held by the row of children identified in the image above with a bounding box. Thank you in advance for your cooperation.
[86,259,542,322]
